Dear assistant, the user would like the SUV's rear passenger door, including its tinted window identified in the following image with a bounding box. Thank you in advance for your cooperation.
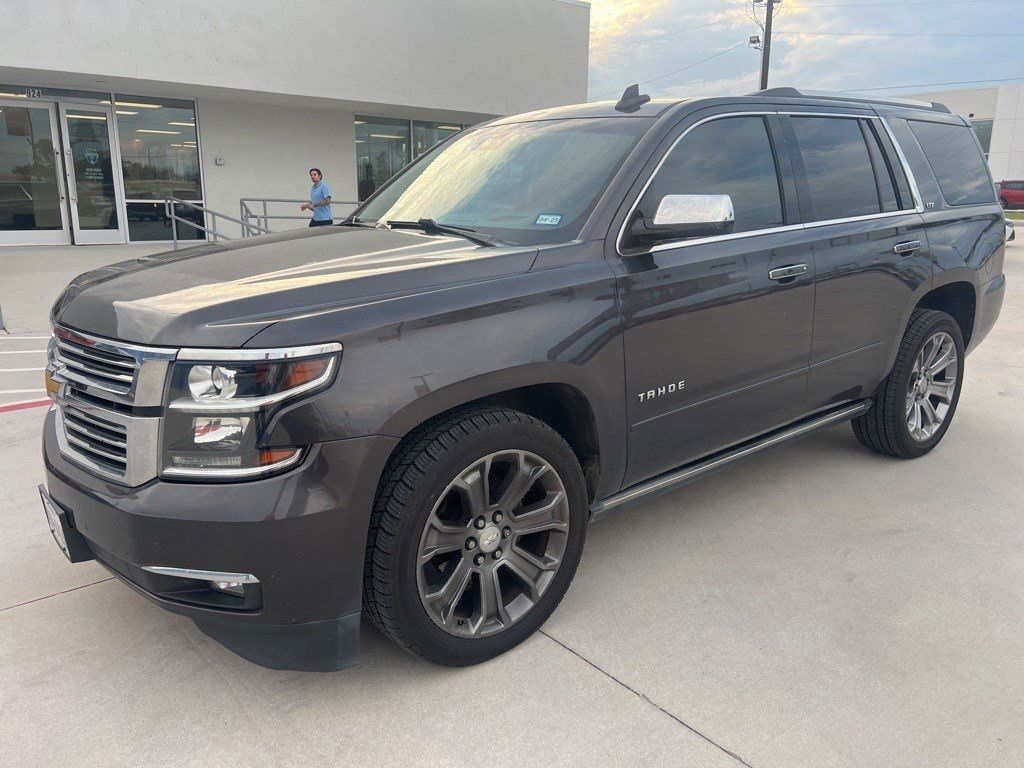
[782,111,933,413]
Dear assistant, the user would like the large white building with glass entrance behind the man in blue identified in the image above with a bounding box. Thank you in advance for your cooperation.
[0,0,590,244]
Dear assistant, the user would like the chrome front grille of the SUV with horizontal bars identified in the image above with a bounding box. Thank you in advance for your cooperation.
[47,328,177,486]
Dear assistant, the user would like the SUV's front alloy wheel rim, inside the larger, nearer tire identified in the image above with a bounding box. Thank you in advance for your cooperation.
[416,451,569,638]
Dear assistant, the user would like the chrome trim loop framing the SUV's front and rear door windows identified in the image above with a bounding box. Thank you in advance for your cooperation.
[615,110,925,258]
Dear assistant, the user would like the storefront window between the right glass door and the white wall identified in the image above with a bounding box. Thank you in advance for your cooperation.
[114,94,203,241]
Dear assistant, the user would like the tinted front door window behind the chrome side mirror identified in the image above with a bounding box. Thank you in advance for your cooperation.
[637,117,782,232]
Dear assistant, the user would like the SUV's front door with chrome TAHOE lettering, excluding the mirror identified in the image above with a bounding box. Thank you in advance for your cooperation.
[616,115,814,484]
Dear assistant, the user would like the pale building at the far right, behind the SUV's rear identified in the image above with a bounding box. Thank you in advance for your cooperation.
[906,80,1024,181]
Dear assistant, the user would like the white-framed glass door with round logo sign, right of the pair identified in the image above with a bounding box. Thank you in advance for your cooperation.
[60,102,127,245]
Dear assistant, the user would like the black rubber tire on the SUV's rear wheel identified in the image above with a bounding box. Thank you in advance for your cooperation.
[853,309,964,459]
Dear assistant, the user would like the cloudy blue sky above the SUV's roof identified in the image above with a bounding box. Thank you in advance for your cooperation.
[589,0,1024,100]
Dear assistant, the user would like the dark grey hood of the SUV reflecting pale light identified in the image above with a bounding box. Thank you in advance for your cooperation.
[52,227,537,347]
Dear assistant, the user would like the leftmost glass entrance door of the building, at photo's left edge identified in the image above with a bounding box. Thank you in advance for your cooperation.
[0,99,71,245]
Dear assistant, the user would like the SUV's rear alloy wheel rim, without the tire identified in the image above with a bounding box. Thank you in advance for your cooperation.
[906,331,959,441]
